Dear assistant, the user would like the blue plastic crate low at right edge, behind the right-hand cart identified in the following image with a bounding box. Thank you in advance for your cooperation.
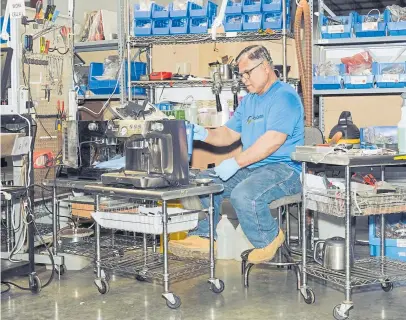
[369,213,406,262]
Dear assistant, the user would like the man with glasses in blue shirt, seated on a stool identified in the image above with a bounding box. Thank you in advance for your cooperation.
[169,46,304,263]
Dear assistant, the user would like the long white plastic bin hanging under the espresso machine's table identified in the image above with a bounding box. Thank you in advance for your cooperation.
[92,207,199,234]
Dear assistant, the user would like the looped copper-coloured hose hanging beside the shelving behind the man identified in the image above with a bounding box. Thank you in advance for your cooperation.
[294,0,313,126]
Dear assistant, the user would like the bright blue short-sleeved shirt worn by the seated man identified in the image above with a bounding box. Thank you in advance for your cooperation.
[226,80,304,172]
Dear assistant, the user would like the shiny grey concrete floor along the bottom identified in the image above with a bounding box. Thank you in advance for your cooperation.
[1,261,406,320]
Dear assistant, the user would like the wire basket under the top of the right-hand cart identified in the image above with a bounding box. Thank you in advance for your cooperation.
[305,188,406,217]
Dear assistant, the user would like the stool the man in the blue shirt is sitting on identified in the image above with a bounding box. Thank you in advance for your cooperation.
[241,193,302,290]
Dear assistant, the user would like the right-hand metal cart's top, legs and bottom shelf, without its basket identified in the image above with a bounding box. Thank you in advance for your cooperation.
[291,148,406,320]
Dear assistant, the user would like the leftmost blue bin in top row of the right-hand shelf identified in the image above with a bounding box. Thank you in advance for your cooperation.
[319,13,354,39]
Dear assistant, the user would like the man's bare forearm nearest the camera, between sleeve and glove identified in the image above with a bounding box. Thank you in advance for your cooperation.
[235,130,287,168]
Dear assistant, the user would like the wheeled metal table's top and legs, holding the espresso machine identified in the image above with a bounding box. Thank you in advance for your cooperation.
[44,179,224,309]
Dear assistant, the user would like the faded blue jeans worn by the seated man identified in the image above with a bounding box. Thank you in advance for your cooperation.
[189,163,302,248]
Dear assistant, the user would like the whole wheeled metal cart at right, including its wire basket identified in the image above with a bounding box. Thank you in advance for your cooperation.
[292,151,406,320]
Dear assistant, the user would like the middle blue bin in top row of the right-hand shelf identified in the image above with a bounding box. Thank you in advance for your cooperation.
[354,10,389,38]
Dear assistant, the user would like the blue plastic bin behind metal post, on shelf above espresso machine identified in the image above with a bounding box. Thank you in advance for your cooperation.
[88,61,147,95]
